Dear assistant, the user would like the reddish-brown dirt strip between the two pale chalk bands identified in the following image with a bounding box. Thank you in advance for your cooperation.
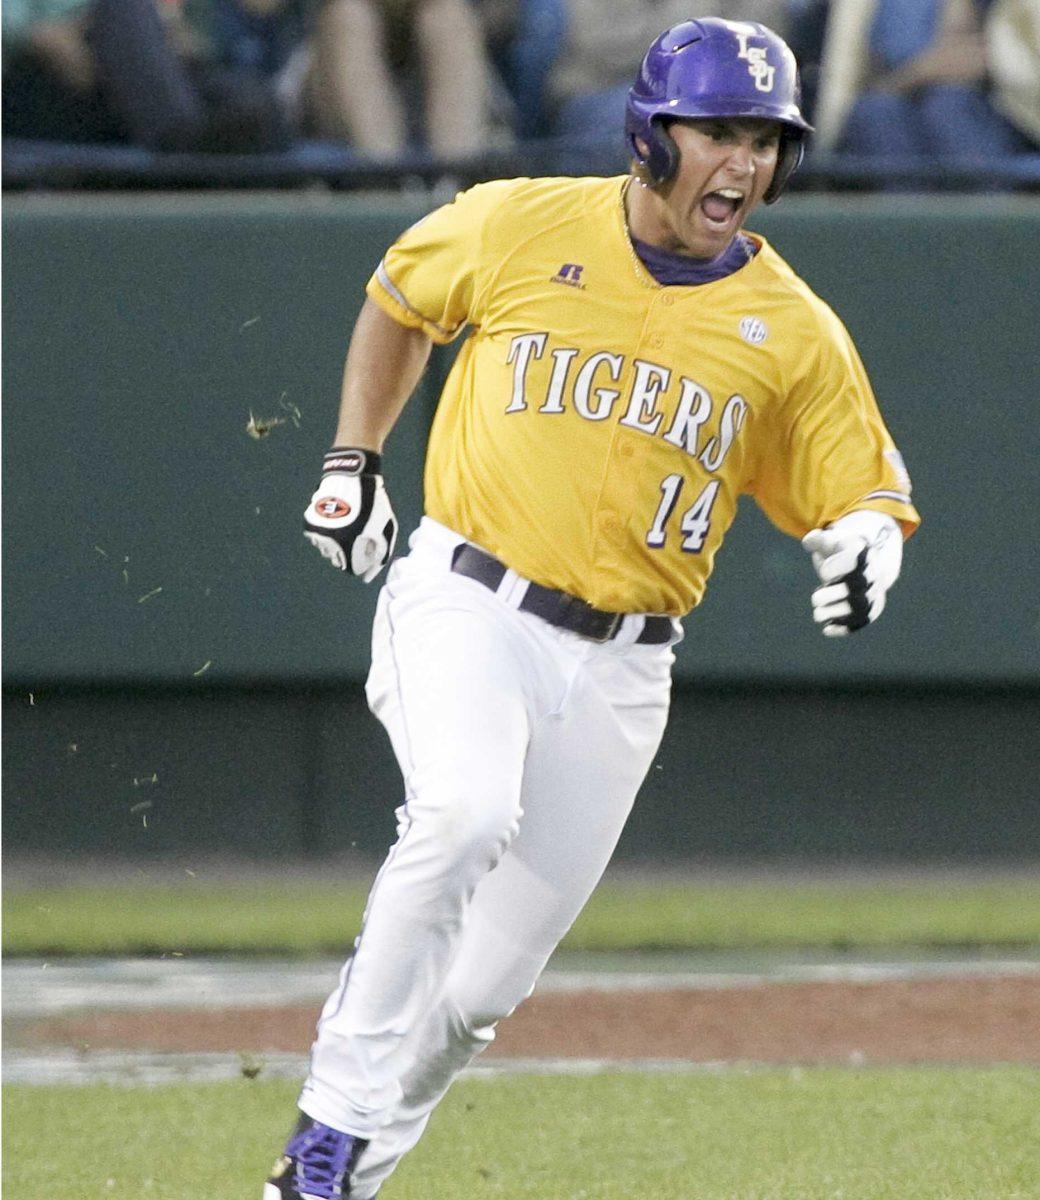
[11,974,1040,1063]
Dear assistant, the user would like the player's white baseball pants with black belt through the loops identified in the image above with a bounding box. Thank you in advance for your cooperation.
[300,517,681,1200]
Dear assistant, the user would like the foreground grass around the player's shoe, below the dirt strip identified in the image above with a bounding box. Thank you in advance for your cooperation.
[4,1067,1040,1200]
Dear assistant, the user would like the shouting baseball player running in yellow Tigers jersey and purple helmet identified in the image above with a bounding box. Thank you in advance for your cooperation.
[264,18,919,1200]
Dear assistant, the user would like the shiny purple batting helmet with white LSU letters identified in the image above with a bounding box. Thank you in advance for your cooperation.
[625,17,812,204]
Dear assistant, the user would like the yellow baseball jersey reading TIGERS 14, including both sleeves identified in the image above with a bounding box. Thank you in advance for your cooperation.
[368,176,919,616]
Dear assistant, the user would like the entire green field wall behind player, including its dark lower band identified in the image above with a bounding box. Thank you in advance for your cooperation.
[2,192,1040,858]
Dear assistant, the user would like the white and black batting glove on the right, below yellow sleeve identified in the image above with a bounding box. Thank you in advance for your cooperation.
[801,509,903,637]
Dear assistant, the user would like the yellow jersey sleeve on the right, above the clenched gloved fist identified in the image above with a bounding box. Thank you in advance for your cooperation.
[751,306,920,538]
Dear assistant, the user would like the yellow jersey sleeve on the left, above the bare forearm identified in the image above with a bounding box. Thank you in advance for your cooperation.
[366,181,509,342]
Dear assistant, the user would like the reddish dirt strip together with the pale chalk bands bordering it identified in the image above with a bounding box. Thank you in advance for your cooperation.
[5,960,1040,1081]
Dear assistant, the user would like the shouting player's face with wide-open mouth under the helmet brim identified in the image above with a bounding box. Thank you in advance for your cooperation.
[653,118,780,258]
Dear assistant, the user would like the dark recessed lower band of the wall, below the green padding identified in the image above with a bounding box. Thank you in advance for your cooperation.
[4,684,1040,869]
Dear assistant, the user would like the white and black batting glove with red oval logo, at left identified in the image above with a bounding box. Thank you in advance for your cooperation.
[303,446,397,583]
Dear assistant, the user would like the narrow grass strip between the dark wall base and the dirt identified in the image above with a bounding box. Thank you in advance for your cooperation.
[4,880,1040,956]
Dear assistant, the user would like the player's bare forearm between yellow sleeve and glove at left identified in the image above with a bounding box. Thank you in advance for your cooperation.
[335,300,431,451]
